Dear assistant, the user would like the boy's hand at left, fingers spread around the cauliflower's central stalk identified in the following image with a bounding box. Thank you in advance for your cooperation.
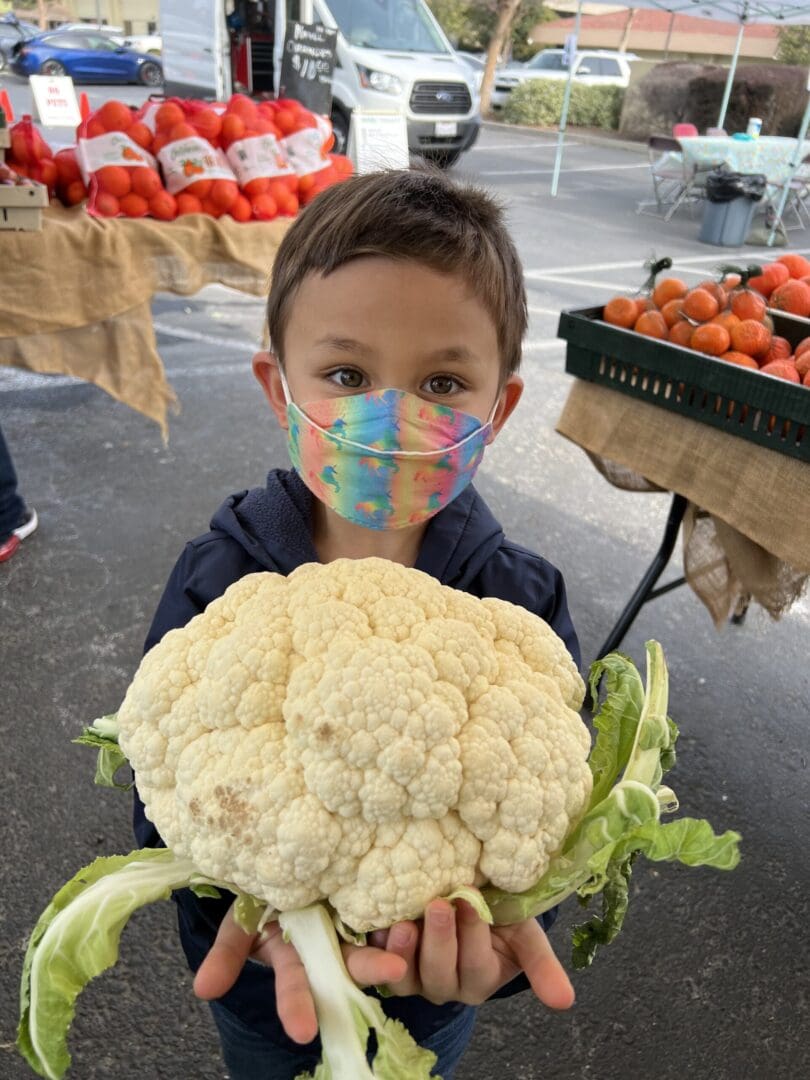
[194,908,407,1043]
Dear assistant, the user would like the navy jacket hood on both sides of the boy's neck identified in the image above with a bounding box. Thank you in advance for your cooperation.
[211,469,503,589]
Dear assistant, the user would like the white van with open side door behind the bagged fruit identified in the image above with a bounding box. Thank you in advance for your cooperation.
[160,0,481,167]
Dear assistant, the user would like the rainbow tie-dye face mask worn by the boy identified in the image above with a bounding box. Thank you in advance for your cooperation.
[282,373,497,529]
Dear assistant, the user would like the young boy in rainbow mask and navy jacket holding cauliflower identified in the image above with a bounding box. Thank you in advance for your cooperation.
[135,172,579,1080]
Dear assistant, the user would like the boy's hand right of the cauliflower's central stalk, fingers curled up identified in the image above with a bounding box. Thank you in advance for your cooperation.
[370,900,573,1009]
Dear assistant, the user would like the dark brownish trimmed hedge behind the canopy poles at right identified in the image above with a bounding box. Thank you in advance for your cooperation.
[620,63,807,139]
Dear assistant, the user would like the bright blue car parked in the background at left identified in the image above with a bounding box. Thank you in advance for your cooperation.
[11,30,163,86]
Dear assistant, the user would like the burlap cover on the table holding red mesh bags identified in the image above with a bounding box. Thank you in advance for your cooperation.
[0,206,289,437]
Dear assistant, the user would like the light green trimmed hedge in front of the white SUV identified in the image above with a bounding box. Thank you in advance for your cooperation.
[503,79,624,131]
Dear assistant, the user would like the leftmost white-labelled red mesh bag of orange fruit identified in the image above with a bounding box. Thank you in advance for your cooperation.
[77,100,177,221]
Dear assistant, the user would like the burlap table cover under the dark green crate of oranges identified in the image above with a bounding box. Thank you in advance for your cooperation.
[556,379,810,627]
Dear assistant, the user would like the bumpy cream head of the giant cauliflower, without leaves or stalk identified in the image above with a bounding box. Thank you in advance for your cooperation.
[119,558,591,930]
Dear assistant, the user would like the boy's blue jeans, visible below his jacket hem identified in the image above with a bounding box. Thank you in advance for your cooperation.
[211,1001,475,1080]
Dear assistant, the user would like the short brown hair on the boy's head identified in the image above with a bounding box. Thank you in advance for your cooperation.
[267,170,528,379]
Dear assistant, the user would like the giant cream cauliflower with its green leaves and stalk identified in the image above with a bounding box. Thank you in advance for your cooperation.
[17,559,739,1080]
